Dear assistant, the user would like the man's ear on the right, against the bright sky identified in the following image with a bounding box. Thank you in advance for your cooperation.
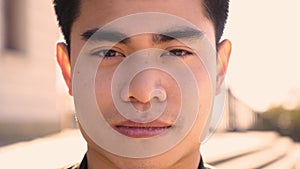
[216,40,231,95]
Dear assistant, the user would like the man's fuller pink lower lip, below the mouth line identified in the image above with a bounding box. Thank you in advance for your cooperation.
[116,126,170,138]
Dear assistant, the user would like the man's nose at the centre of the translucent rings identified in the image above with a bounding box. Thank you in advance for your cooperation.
[122,69,167,104]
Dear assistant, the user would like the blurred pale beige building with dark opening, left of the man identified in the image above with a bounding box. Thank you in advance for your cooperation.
[0,0,72,145]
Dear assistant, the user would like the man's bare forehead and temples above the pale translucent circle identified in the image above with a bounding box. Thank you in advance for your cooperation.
[71,0,215,58]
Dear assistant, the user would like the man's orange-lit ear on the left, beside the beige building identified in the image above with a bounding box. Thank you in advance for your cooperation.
[56,43,72,96]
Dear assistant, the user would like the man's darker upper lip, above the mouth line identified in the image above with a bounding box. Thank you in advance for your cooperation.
[115,120,172,128]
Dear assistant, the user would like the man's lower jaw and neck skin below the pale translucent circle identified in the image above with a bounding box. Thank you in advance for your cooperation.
[80,121,200,169]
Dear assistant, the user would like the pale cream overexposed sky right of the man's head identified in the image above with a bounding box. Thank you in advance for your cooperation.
[223,0,300,111]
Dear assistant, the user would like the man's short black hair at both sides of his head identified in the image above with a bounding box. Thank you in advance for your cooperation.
[53,0,229,52]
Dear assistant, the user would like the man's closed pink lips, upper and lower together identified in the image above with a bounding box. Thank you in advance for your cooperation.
[115,121,172,138]
